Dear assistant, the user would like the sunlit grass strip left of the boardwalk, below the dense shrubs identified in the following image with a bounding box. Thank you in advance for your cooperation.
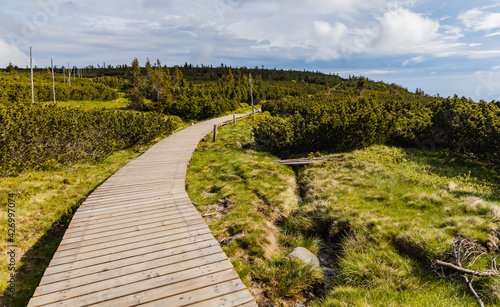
[0,148,144,306]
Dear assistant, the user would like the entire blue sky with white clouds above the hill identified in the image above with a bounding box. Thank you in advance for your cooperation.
[0,0,500,101]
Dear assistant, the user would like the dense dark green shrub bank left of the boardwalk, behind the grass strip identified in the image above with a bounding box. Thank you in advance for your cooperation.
[0,103,177,176]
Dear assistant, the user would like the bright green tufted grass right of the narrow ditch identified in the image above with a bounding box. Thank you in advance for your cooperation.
[292,146,500,306]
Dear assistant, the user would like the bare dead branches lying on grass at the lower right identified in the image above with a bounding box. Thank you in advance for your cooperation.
[433,237,500,307]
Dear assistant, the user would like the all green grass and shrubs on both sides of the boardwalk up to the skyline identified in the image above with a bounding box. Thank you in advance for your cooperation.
[0,60,500,306]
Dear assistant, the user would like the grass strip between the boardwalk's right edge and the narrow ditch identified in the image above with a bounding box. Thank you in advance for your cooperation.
[187,117,322,304]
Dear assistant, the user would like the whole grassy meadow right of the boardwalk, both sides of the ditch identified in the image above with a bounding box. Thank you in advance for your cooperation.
[187,116,500,306]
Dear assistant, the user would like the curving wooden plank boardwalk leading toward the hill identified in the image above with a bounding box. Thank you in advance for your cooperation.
[28,115,257,307]
